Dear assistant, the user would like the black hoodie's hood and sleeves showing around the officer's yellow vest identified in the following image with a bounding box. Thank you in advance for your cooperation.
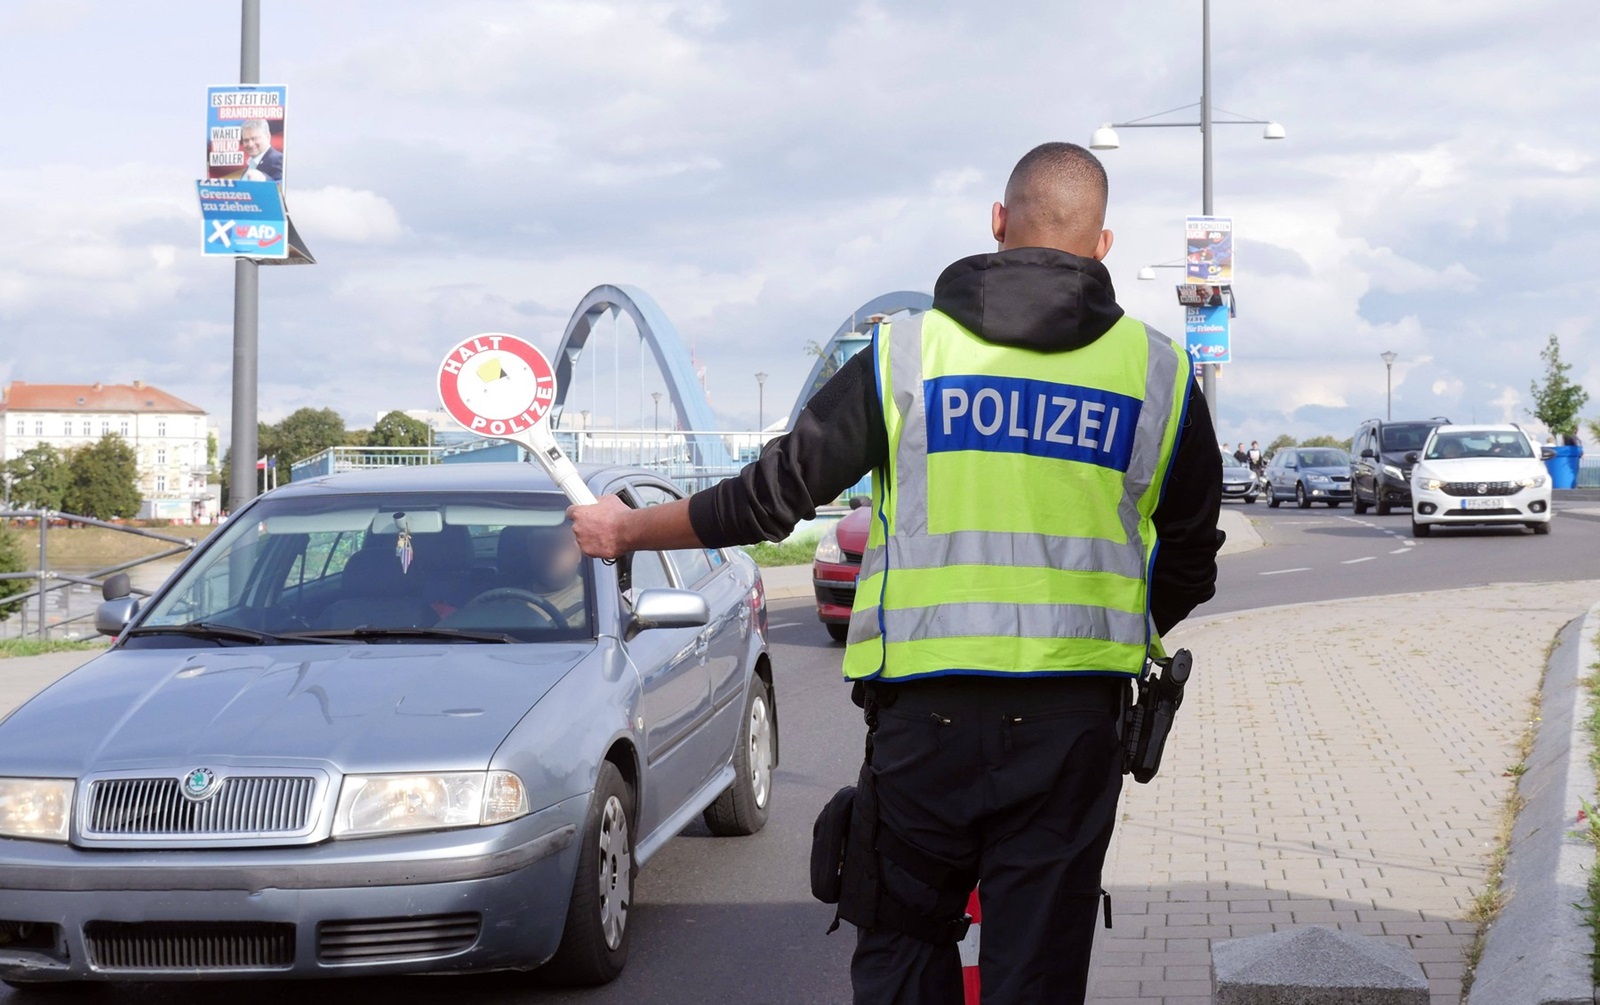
[690,248,1222,634]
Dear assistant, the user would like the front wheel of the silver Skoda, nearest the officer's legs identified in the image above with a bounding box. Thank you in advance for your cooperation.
[539,760,635,986]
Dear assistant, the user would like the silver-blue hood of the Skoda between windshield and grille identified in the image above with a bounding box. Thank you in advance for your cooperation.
[0,643,595,778]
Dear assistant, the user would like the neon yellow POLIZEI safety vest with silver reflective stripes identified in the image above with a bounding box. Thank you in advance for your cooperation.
[845,310,1190,679]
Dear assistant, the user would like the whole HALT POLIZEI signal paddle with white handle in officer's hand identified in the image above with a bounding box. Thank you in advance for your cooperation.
[438,331,595,506]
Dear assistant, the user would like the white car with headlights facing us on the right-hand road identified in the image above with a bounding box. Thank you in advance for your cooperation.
[1411,426,1550,538]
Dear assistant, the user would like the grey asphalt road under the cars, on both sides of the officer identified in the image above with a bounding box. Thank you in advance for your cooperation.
[12,504,1600,1005]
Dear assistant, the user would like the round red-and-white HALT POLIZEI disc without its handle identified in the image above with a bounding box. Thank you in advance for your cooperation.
[438,331,555,437]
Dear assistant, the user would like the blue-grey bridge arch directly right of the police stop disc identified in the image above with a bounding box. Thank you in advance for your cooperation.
[550,283,733,469]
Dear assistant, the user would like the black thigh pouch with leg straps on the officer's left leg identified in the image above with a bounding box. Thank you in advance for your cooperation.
[811,682,976,946]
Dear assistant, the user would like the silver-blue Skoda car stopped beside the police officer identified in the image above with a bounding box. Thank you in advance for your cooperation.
[0,464,778,984]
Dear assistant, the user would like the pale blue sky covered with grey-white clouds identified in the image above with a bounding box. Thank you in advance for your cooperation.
[0,0,1600,442]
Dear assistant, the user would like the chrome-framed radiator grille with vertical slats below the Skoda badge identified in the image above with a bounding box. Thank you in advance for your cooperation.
[83,775,317,839]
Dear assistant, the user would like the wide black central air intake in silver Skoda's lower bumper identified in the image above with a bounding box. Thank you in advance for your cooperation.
[83,922,294,970]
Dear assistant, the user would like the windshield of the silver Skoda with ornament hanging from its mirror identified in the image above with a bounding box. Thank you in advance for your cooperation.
[131,491,595,645]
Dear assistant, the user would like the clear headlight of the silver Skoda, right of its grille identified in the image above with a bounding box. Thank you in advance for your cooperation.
[333,771,528,837]
